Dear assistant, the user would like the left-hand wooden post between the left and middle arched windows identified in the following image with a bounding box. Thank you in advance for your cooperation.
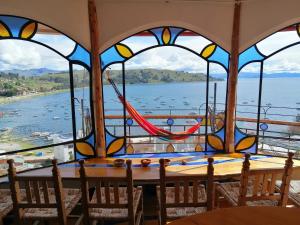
[88,0,106,157]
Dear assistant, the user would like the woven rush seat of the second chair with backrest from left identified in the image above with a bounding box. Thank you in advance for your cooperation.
[89,187,142,219]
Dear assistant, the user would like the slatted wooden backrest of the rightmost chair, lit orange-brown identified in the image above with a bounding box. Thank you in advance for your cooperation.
[238,153,294,206]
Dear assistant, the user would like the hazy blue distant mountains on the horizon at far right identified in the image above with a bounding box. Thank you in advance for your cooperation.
[210,73,300,79]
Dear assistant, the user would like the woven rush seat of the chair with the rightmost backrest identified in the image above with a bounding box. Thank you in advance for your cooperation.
[216,181,278,206]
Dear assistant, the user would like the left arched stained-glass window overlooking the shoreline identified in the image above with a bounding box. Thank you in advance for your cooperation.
[0,16,94,178]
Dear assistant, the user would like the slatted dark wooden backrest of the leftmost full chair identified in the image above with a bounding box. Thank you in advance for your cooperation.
[7,159,67,224]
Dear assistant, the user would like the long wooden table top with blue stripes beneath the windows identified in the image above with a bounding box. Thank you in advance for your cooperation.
[2,153,300,182]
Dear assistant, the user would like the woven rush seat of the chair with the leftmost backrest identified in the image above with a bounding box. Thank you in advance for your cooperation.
[24,189,81,220]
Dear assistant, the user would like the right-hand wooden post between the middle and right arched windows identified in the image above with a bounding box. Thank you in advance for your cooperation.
[225,0,241,153]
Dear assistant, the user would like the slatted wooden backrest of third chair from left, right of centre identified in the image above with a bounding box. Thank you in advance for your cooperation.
[159,158,214,221]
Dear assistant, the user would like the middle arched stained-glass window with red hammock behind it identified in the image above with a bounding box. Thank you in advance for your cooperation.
[100,27,229,155]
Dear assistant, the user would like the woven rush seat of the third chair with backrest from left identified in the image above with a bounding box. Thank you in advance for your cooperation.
[156,185,207,218]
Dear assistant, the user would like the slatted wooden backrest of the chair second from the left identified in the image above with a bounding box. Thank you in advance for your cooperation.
[79,160,134,224]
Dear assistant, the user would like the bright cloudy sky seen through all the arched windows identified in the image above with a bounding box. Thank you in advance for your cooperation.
[0,31,300,73]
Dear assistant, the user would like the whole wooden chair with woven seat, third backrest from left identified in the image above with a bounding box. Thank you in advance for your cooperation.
[156,158,214,225]
